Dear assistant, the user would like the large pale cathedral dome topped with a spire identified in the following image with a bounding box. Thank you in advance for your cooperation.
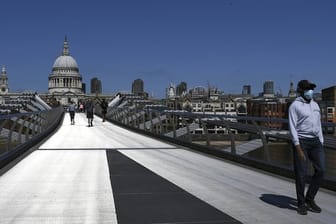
[48,37,84,105]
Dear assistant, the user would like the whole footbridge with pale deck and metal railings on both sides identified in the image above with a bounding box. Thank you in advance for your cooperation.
[0,95,336,224]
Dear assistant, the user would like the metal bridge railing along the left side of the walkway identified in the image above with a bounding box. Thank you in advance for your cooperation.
[0,107,64,168]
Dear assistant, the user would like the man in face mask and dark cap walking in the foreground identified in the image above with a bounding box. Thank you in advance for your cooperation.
[288,80,325,215]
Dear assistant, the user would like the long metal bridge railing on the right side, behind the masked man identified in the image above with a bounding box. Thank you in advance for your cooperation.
[96,103,336,190]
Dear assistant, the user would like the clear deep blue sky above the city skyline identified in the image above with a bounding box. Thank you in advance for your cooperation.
[0,0,336,98]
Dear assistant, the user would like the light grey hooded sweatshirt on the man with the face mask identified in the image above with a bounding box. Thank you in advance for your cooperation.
[288,96,324,146]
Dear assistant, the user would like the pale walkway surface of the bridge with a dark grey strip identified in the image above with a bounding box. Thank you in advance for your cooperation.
[0,114,336,224]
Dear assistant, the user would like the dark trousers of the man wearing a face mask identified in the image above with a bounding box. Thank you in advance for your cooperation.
[293,138,325,206]
